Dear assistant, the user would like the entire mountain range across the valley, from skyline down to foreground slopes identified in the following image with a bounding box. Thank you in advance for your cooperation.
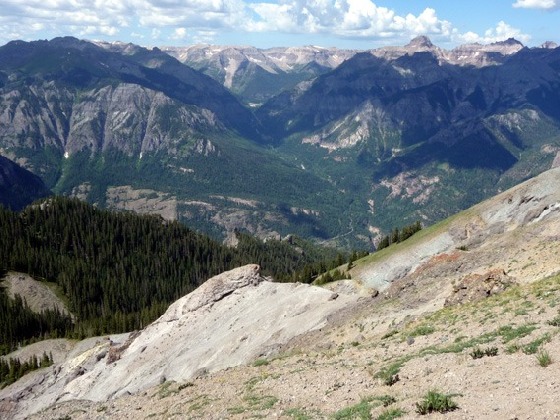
[0,37,560,248]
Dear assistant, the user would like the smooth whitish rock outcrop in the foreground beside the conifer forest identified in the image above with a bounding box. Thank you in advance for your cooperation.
[0,265,357,418]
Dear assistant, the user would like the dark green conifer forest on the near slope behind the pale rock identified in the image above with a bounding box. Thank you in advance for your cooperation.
[0,197,346,353]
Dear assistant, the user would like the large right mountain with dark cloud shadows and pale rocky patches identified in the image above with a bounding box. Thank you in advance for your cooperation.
[257,40,560,243]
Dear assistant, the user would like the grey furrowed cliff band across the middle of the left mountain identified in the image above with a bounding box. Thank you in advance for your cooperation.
[0,83,225,157]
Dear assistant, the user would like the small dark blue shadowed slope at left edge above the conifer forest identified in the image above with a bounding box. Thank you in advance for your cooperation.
[0,156,51,210]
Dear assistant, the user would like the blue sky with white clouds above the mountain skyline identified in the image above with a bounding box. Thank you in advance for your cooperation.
[0,0,560,49]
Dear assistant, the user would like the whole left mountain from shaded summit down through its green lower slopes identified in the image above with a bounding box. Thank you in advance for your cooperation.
[0,38,348,244]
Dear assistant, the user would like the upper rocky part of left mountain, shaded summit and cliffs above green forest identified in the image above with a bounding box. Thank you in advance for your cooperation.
[0,38,256,180]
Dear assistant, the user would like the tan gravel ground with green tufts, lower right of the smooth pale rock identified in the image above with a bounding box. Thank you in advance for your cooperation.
[21,277,560,419]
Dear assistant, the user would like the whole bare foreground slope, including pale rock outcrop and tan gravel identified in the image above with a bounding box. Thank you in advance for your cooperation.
[0,168,560,418]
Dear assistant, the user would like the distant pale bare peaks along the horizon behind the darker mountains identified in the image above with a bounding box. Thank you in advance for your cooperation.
[170,36,528,106]
